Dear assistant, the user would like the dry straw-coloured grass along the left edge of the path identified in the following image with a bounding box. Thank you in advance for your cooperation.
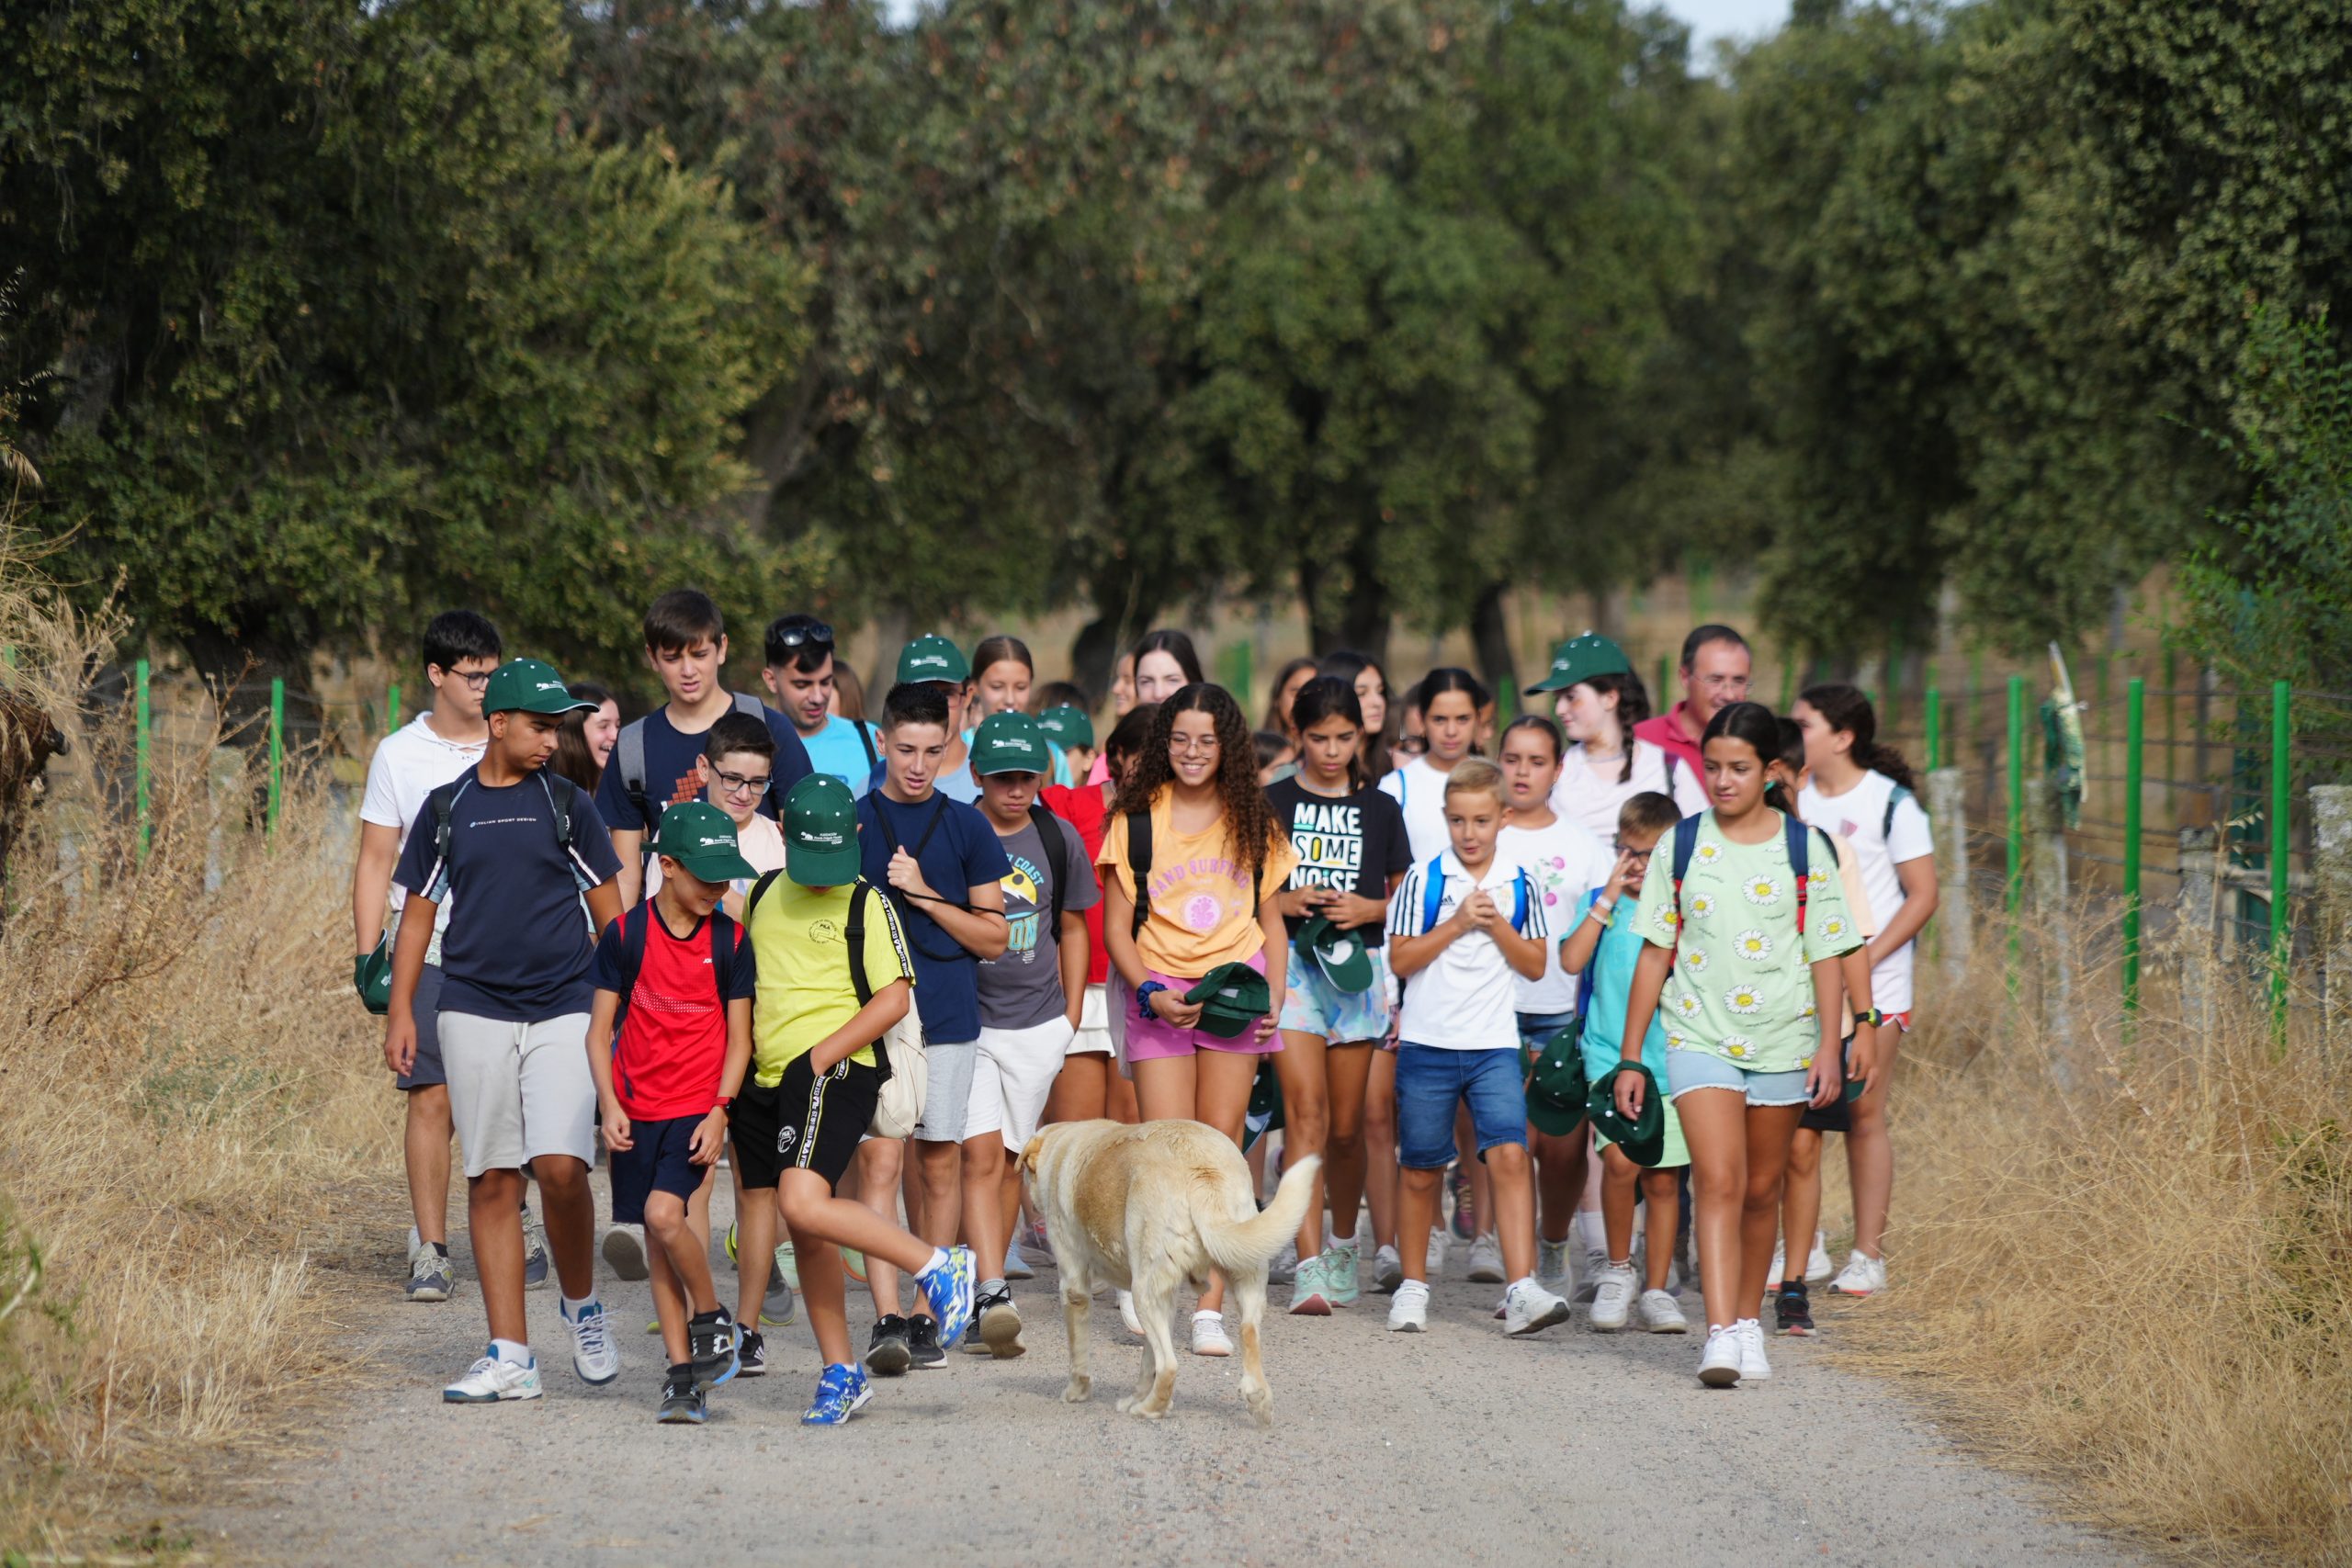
[0,531,400,1554]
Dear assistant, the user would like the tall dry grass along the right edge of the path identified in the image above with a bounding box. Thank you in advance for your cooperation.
[1839,936,2352,1561]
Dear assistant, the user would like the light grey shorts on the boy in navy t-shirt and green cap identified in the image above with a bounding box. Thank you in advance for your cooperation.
[440,1013,595,1180]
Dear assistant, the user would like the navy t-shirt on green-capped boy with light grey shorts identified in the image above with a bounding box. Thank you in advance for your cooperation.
[393,766,621,1022]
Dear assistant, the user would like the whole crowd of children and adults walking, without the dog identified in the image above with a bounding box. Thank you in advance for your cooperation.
[353,590,1936,1425]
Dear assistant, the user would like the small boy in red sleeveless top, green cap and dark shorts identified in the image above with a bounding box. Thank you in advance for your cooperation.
[588,802,760,1425]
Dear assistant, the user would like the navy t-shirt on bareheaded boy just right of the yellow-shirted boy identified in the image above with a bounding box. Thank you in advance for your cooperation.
[860,790,1013,1046]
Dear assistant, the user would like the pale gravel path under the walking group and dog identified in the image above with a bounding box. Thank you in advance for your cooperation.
[188,1187,2131,1568]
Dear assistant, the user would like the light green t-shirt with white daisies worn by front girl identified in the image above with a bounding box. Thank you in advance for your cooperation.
[1642,811,1863,1072]
